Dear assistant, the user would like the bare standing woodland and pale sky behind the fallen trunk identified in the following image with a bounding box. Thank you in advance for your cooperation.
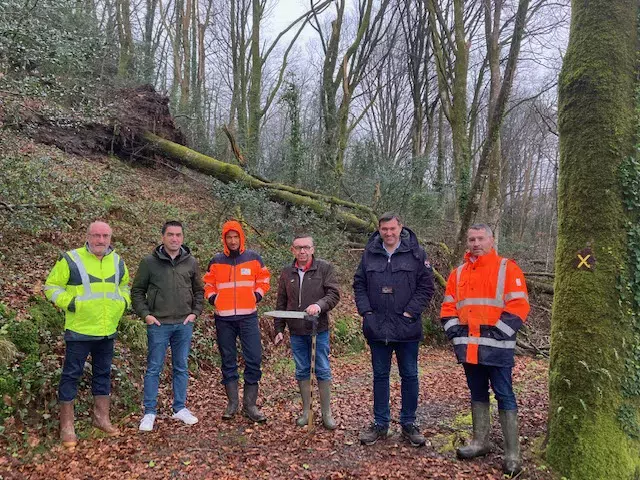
[0,0,570,262]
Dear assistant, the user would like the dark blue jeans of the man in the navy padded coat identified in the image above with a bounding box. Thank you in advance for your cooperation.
[369,342,420,428]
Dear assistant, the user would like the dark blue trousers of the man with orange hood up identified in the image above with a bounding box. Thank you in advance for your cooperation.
[216,315,262,385]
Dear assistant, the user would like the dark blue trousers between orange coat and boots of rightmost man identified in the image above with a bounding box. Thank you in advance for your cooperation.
[462,363,518,410]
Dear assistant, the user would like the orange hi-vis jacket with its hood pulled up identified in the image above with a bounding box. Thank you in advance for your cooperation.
[203,220,270,320]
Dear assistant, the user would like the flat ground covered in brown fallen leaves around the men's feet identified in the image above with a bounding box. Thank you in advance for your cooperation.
[0,346,553,479]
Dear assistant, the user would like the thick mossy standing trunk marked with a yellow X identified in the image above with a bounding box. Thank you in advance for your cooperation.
[547,0,640,480]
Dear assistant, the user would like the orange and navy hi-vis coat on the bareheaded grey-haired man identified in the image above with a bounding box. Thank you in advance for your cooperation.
[440,249,529,367]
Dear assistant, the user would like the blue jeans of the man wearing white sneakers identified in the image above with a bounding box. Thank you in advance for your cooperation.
[144,322,193,414]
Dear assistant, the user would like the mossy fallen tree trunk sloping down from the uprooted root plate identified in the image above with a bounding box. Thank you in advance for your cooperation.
[143,132,376,233]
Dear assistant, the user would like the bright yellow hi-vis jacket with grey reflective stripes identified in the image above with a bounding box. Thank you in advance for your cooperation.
[44,245,131,337]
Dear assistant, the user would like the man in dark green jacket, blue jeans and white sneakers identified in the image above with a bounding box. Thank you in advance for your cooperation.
[131,220,204,432]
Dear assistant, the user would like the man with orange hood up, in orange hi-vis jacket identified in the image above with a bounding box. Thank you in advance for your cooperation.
[204,220,270,422]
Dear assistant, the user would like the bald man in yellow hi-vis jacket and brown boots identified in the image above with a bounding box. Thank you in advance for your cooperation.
[44,222,131,447]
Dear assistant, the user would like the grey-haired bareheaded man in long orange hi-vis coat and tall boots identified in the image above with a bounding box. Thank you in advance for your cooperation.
[440,224,529,475]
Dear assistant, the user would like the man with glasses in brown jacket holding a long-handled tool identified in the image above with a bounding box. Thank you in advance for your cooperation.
[274,235,340,430]
